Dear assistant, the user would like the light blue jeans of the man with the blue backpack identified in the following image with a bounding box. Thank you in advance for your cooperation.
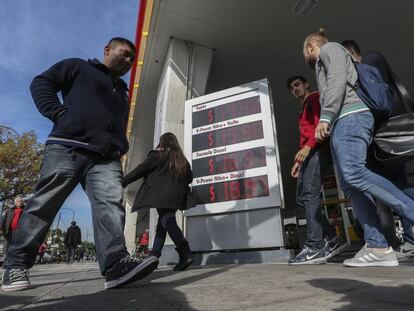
[331,111,414,248]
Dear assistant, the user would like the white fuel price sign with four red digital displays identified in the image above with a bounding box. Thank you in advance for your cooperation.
[184,79,281,216]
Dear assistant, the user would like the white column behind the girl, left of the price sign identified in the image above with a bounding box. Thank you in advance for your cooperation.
[149,38,213,245]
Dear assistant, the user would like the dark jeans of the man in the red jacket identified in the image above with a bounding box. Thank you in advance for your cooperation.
[296,148,336,249]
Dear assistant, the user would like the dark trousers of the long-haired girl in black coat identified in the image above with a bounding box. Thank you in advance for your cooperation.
[152,208,185,256]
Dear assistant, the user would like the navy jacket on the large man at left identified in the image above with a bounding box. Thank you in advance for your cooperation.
[30,58,128,155]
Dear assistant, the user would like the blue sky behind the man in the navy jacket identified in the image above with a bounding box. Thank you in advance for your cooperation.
[0,0,139,240]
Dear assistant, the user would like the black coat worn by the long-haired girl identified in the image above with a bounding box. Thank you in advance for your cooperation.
[122,150,193,212]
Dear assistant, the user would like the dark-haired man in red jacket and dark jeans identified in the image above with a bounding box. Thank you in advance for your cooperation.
[287,76,347,265]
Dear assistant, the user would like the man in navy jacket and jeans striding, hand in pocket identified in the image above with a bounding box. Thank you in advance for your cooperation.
[2,38,158,291]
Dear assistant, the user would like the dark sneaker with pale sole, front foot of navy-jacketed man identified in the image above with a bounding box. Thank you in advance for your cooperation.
[105,256,158,289]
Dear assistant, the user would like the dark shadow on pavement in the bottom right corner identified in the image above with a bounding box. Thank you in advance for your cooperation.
[307,278,414,311]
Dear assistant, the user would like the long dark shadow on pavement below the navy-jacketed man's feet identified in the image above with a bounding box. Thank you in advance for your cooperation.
[0,266,233,311]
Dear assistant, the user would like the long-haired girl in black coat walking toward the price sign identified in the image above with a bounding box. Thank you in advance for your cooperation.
[122,133,193,271]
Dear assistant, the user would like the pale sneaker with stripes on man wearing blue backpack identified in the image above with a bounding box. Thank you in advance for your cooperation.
[343,245,398,267]
